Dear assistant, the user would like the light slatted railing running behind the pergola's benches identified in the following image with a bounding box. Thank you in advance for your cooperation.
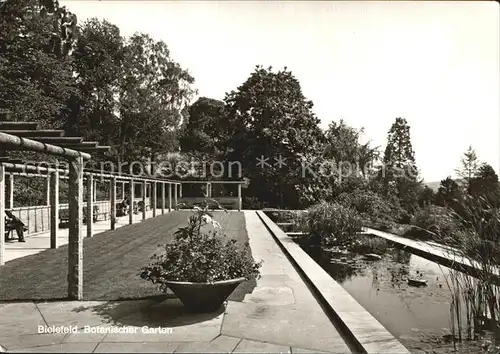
[7,198,151,235]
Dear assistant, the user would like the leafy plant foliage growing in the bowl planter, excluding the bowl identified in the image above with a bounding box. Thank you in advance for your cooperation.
[140,198,261,291]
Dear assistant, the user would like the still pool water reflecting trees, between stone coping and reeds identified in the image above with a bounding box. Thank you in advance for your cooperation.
[303,243,492,353]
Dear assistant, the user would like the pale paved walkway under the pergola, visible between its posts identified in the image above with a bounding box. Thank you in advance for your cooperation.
[5,209,164,262]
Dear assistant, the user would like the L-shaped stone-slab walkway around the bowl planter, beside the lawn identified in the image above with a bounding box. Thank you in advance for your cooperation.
[0,212,350,353]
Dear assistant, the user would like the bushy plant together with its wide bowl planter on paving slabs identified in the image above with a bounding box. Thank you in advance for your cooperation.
[140,198,261,312]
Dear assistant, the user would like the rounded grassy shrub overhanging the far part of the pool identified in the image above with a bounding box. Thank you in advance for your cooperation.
[301,202,362,247]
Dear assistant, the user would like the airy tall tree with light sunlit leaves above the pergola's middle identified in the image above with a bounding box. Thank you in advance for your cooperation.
[115,33,194,166]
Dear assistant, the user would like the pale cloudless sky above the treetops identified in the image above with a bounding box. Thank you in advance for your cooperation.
[60,0,500,182]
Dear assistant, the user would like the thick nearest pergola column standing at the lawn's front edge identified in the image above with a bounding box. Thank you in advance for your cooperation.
[68,157,83,300]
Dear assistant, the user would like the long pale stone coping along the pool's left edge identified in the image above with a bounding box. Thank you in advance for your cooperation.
[256,211,411,354]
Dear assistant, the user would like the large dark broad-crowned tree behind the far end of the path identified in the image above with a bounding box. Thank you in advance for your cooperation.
[225,66,323,207]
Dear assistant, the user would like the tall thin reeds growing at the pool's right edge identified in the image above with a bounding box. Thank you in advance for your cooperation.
[440,196,500,352]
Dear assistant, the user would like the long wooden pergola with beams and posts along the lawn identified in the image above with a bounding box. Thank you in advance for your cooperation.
[0,121,180,300]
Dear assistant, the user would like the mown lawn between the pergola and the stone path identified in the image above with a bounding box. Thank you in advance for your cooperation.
[0,211,256,301]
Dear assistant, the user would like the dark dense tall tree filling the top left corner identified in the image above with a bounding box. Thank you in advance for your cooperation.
[0,0,77,125]
